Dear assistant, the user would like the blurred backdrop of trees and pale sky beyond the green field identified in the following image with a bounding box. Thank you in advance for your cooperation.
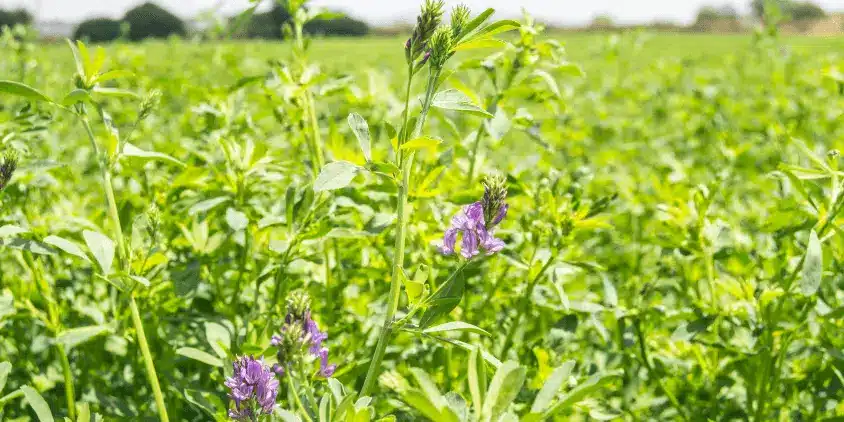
[0,0,844,42]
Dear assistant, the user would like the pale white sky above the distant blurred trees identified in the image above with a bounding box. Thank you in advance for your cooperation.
[0,0,844,24]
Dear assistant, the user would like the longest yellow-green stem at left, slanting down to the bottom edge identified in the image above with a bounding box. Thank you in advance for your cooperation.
[82,116,170,422]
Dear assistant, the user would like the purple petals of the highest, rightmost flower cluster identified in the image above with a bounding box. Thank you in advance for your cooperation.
[440,201,509,259]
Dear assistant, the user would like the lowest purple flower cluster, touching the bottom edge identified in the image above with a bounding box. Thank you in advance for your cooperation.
[225,356,278,421]
